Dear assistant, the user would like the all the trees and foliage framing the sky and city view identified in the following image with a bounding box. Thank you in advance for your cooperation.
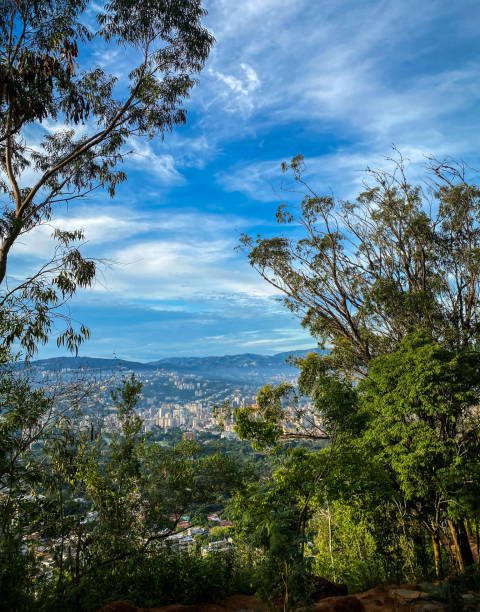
[0,0,480,612]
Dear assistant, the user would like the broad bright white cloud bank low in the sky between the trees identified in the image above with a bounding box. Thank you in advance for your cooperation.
[5,206,274,304]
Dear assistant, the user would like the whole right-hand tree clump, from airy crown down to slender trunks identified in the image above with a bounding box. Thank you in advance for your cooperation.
[237,156,480,578]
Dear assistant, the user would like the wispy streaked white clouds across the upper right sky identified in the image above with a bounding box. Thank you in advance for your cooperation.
[192,0,480,171]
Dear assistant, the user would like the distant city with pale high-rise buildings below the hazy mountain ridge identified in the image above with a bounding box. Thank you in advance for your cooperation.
[19,351,318,436]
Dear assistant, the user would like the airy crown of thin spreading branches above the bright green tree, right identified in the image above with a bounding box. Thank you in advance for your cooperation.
[241,156,480,378]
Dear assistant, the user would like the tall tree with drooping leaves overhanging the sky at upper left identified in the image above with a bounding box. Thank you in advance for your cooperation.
[0,0,213,354]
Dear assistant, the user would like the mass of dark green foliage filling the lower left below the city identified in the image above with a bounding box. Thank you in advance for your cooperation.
[0,370,255,610]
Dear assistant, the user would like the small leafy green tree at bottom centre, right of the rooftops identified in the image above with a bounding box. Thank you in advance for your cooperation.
[228,449,324,610]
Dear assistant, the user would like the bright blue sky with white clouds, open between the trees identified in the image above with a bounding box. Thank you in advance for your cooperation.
[10,0,480,361]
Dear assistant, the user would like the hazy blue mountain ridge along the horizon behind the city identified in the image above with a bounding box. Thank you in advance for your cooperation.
[18,348,318,380]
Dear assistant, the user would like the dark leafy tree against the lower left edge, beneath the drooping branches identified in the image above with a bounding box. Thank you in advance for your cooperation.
[0,354,86,610]
